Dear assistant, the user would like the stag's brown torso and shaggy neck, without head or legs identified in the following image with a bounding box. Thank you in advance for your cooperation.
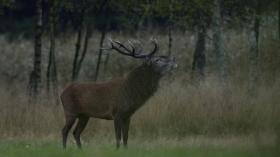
[61,65,160,120]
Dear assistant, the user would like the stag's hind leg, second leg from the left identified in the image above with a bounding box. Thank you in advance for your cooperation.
[73,117,89,149]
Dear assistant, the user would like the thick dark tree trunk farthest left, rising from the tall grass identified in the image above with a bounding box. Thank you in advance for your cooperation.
[29,0,43,98]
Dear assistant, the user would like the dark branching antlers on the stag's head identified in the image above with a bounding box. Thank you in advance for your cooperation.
[109,39,158,58]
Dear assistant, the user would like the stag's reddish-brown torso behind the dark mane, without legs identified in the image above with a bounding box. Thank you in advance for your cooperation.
[61,79,123,120]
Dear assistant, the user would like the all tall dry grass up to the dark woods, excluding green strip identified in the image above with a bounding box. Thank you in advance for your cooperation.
[0,23,280,144]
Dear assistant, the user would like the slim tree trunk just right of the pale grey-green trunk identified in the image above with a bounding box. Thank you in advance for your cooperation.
[249,1,261,93]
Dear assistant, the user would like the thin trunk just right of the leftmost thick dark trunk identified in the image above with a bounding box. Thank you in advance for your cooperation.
[47,0,58,104]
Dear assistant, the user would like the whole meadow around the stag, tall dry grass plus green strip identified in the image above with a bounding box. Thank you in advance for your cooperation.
[0,25,280,157]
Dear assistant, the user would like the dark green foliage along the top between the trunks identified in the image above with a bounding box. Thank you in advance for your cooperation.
[0,0,278,35]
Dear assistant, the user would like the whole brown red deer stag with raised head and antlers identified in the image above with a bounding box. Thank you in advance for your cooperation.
[61,40,176,148]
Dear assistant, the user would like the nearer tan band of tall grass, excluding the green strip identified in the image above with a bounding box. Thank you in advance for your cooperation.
[0,78,280,138]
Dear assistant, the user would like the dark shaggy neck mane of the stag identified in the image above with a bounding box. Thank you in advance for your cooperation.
[123,64,161,112]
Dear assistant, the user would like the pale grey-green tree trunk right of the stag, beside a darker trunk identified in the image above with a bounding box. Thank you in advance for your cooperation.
[213,0,226,82]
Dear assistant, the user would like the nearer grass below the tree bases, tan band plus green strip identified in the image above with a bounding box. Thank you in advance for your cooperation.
[0,75,280,157]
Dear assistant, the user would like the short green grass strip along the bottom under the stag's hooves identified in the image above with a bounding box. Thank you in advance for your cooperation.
[0,140,274,157]
